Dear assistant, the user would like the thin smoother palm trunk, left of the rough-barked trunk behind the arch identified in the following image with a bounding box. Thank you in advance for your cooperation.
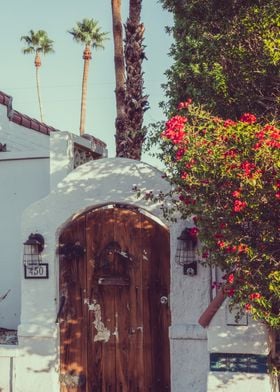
[111,0,125,156]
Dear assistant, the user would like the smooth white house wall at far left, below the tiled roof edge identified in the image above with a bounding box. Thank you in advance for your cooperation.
[0,105,50,329]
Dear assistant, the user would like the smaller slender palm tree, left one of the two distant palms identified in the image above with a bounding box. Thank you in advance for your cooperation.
[20,30,54,122]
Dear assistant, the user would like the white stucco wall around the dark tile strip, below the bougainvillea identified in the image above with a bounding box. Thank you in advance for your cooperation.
[207,300,278,392]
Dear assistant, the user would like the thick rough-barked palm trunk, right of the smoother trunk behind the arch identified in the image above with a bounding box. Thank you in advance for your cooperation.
[124,0,148,160]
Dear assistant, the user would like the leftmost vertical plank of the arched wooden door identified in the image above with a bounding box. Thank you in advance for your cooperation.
[59,217,87,392]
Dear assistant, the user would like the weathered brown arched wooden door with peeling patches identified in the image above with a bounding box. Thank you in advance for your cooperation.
[59,206,170,392]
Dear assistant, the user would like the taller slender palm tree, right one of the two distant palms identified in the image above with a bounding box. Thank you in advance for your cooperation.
[68,18,108,135]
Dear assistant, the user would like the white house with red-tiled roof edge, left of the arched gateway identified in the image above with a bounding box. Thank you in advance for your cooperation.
[0,91,107,329]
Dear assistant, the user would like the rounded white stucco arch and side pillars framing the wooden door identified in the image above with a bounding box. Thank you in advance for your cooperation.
[13,158,210,392]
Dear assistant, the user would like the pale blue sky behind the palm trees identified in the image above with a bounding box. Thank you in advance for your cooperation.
[0,0,172,162]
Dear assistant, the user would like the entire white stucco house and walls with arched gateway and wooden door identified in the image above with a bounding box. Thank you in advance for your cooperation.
[0,93,277,392]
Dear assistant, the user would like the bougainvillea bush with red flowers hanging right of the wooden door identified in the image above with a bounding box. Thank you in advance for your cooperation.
[151,103,280,328]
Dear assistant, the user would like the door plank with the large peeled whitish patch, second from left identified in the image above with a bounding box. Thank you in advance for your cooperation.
[87,209,116,392]
